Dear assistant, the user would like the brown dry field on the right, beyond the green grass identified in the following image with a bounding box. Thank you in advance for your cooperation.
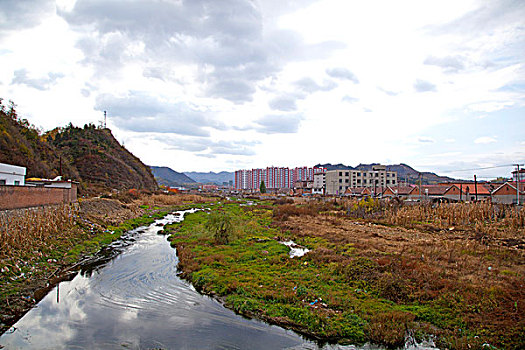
[274,200,525,349]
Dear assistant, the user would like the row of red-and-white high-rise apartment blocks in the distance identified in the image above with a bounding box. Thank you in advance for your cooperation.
[235,167,326,190]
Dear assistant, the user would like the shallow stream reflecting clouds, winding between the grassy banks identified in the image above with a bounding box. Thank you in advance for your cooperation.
[0,210,434,349]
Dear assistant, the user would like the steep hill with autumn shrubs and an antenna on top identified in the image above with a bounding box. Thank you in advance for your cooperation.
[0,100,157,192]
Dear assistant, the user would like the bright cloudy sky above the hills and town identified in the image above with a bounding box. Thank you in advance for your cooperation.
[0,0,525,178]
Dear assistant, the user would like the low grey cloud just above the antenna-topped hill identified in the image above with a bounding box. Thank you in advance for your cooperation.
[95,91,226,136]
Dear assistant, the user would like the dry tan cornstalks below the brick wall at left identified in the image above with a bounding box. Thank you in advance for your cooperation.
[0,205,78,258]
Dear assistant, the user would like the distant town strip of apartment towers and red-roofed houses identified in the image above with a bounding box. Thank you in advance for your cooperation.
[230,164,525,204]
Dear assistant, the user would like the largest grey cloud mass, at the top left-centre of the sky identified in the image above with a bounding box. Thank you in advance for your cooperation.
[58,0,342,103]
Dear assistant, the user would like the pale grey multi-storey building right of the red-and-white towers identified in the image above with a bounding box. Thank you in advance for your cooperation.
[325,165,397,195]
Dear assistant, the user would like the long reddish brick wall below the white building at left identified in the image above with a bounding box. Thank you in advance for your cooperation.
[0,184,77,210]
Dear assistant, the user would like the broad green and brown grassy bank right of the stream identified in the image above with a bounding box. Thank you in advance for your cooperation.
[166,198,525,349]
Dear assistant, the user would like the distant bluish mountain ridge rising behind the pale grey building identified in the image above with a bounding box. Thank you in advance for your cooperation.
[316,163,456,185]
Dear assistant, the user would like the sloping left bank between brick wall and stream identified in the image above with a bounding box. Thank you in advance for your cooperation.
[0,195,213,333]
